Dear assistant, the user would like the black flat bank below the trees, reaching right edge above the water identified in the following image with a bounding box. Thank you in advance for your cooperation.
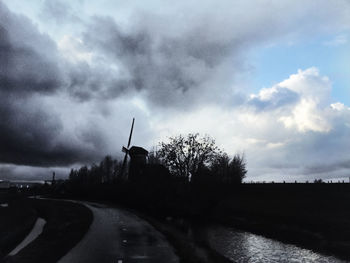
[60,182,350,262]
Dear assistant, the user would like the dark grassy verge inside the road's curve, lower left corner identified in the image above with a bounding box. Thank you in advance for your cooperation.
[0,193,92,263]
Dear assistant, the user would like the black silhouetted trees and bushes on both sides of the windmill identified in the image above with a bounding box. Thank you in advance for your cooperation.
[69,133,247,188]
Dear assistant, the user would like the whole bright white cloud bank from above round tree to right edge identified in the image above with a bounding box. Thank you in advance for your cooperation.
[150,67,350,181]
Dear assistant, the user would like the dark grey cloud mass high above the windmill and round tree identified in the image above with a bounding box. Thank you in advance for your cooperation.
[79,17,242,107]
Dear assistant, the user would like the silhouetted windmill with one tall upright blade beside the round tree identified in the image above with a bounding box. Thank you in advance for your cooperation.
[121,118,148,180]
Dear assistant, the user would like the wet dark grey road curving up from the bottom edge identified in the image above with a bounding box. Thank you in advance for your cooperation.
[59,202,179,263]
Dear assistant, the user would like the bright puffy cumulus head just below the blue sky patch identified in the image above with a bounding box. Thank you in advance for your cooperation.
[249,68,331,132]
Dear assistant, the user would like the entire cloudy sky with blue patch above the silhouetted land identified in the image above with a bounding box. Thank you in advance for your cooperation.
[0,0,350,181]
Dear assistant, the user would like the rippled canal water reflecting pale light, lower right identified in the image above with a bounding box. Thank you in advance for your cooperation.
[208,227,346,263]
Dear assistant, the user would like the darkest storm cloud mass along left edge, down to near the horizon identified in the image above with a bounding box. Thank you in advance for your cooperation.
[0,3,103,166]
